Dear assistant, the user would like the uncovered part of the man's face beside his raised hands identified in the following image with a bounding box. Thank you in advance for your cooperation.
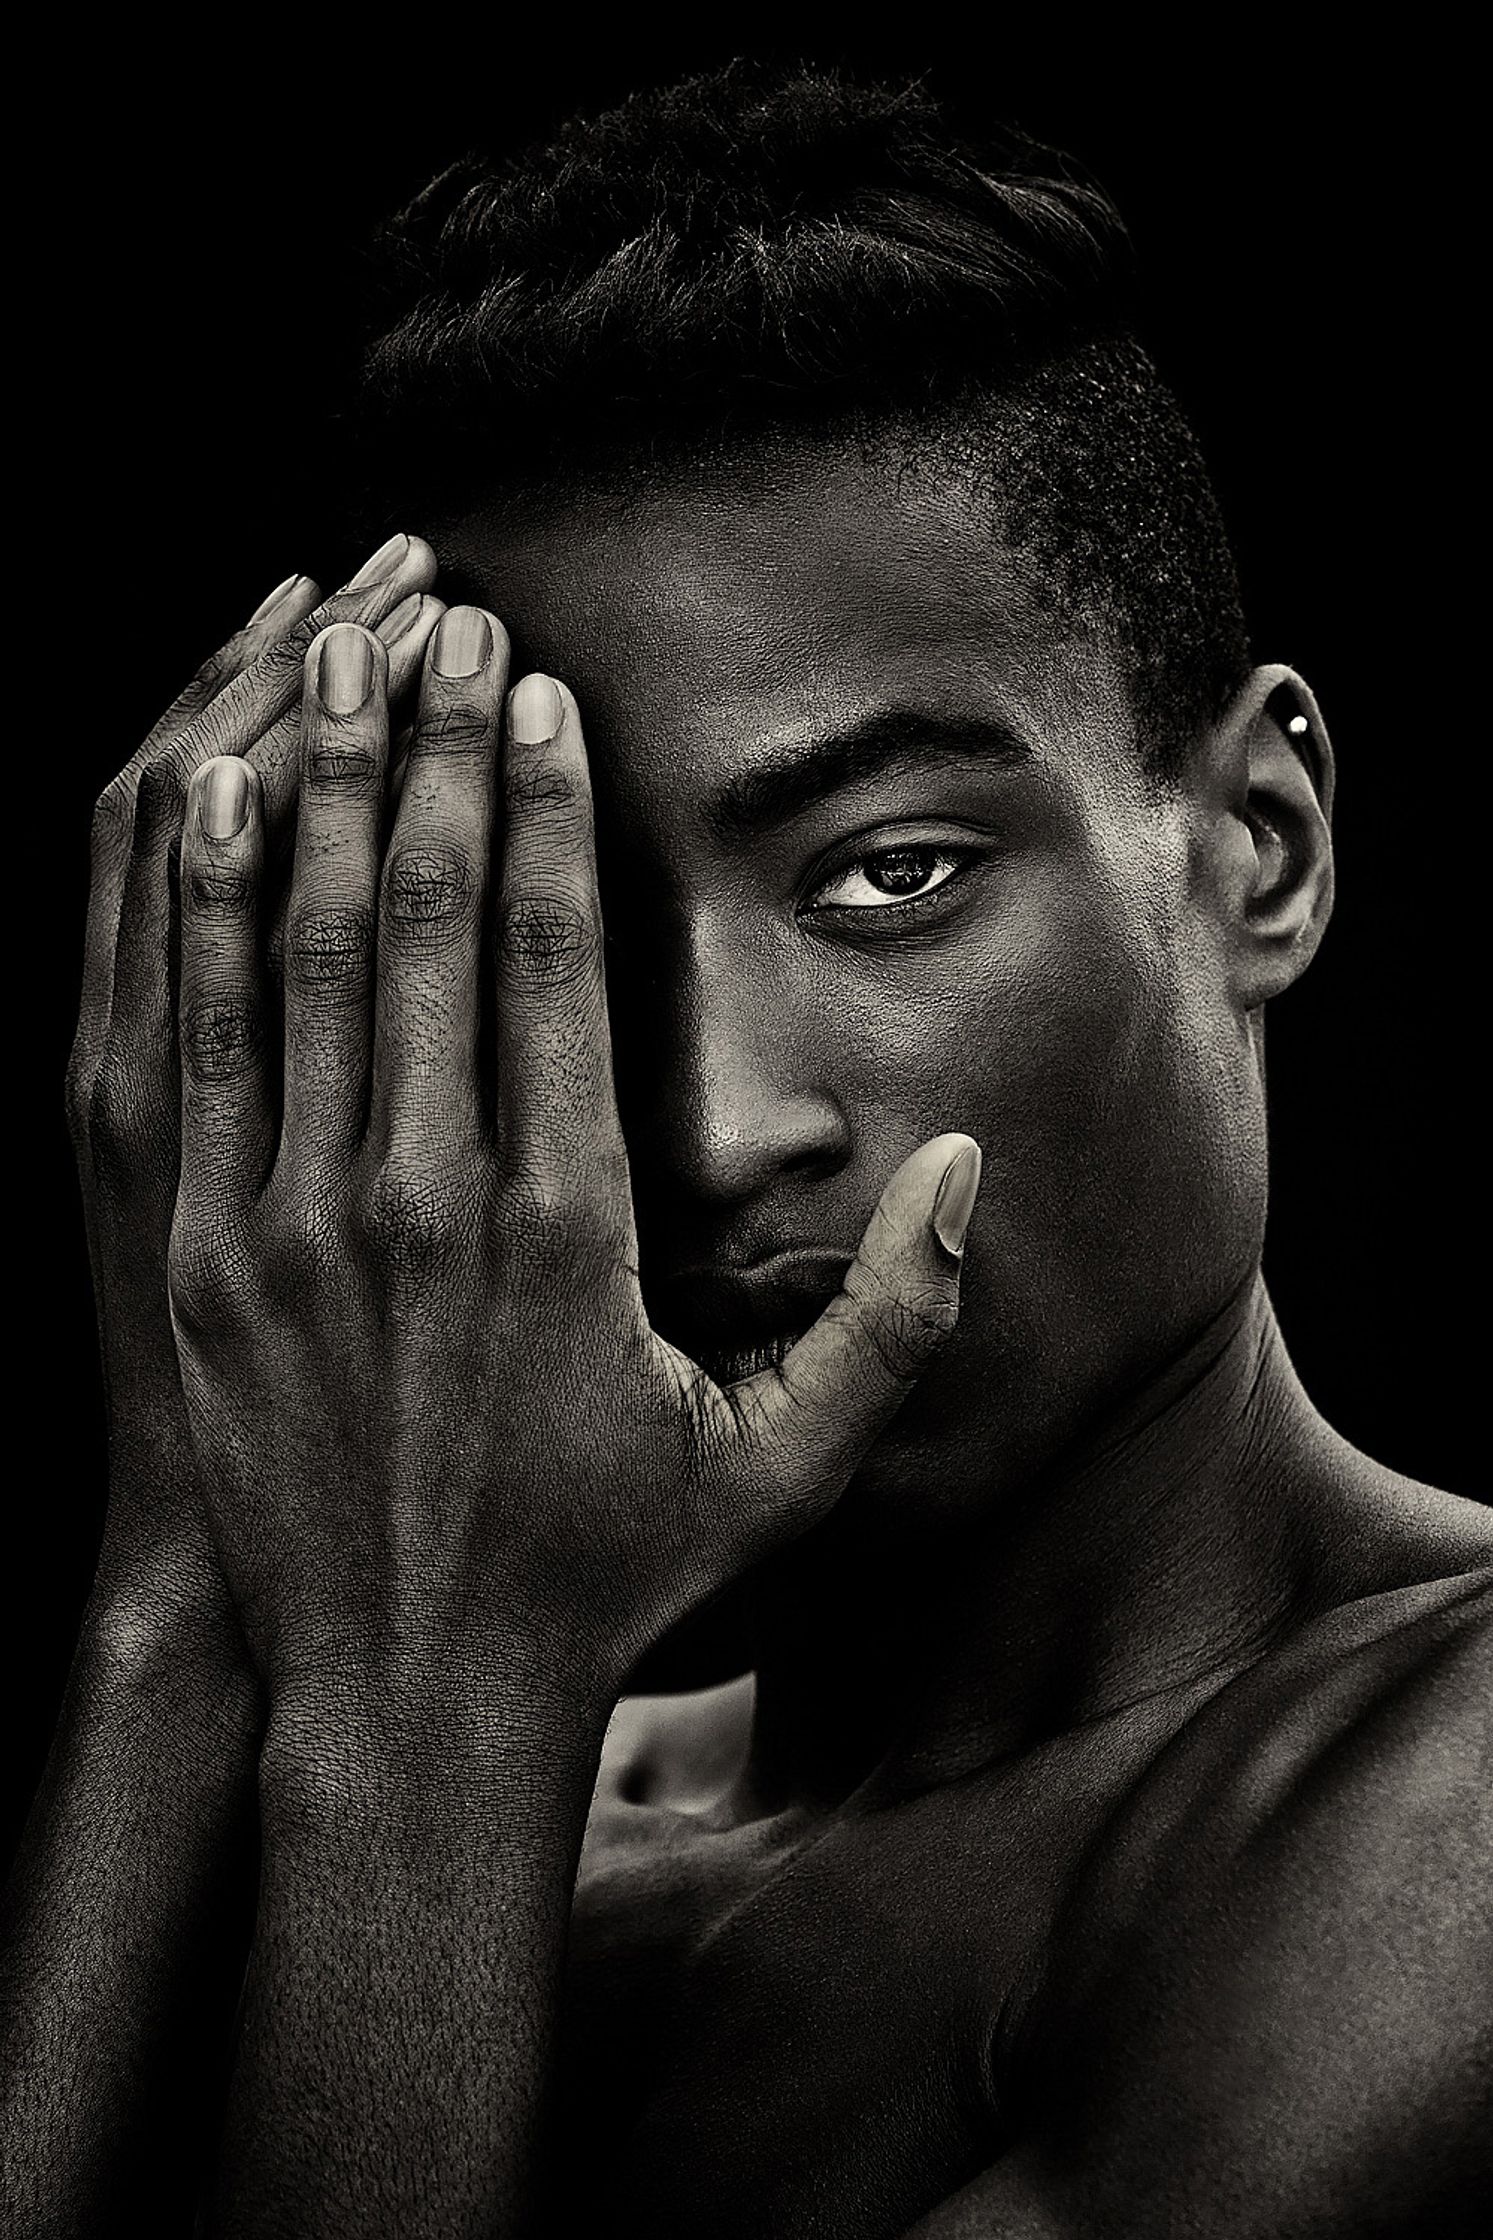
[436,436,1265,1519]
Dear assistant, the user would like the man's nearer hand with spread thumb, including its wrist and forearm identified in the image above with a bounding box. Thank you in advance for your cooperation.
[170,607,978,2233]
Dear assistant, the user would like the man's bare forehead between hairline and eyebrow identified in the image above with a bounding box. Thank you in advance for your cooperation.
[436,450,1130,780]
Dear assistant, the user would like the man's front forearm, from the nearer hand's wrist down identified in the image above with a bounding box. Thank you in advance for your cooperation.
[213,1658,611,2240]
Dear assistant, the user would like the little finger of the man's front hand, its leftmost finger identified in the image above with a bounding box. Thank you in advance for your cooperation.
[181,755,271,1205]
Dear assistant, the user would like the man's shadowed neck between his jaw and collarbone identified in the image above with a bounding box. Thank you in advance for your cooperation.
[745,1277,1372,1810]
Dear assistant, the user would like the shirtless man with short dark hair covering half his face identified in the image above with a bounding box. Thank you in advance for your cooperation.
[7,72,1493,2240]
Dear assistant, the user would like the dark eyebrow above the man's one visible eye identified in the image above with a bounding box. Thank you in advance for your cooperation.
[707,708,1032,844]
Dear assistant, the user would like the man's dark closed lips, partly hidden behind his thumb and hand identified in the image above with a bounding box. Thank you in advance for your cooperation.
[642,1248,851,1384]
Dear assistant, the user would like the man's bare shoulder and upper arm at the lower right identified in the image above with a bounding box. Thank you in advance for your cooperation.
[993,1566,1493,2236]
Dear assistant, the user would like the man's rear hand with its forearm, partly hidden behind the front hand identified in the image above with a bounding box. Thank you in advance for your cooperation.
[0,540,441,2233]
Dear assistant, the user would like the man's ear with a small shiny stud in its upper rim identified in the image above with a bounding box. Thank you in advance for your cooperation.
[1195,663,1334,1010]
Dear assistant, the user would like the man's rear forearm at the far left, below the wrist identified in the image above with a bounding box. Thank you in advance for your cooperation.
[0,1548,260,2236]
